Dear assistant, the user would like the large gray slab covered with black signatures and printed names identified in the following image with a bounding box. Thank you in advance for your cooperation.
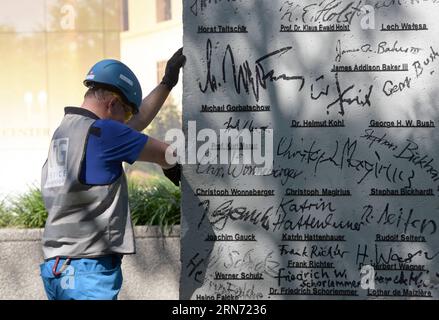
[180,0,439,299]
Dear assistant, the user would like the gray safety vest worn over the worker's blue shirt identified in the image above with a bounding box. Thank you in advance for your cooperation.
[41,108,135,259]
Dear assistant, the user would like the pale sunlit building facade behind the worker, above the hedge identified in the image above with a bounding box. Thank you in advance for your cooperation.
[0,0,182,200]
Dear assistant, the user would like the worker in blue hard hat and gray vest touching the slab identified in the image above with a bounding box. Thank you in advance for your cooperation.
[40,49,185,299]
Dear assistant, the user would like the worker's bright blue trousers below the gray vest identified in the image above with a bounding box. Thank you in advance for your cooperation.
[40,255,122,300]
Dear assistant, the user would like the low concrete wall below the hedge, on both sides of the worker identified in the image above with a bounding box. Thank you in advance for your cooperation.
[0,226,180,300]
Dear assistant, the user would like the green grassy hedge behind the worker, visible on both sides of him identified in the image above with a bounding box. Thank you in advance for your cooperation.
[0,177,181,230]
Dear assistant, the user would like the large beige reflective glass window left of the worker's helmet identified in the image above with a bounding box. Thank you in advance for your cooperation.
[0,0,123,198]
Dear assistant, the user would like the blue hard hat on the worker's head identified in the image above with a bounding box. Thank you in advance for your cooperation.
[84,59,142,113]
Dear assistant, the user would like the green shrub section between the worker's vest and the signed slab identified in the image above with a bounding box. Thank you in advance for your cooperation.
[129,177,181,230]
